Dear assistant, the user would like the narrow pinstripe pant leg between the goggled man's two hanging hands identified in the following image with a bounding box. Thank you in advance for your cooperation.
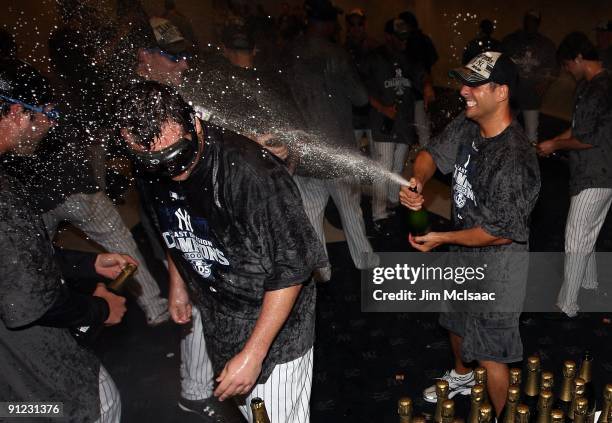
[181,306,214,400]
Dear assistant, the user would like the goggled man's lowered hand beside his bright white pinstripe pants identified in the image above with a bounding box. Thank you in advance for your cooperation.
[214,350,262,401]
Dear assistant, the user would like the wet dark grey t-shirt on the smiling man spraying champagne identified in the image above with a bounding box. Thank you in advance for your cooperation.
[427,113,540,251]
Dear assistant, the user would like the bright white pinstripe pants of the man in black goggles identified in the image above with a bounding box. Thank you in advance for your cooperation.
[236,347,313,423]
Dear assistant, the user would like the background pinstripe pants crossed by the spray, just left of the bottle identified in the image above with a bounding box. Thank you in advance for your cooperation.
[372,141,408,220]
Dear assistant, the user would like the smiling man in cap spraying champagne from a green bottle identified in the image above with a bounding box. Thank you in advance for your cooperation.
[400,52,540,415]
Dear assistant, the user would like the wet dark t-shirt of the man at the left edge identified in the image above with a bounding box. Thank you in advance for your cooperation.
[0,173,100,422]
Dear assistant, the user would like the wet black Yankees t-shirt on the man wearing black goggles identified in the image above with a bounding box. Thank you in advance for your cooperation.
[146,126,326,383]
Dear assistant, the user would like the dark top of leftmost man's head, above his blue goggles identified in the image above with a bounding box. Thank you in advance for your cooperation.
[0,59,59,119]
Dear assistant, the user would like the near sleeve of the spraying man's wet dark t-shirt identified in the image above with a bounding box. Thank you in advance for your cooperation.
[477,148,540,243]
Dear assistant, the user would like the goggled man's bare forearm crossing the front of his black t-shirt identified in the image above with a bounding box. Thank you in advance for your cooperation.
[243,285,302,361]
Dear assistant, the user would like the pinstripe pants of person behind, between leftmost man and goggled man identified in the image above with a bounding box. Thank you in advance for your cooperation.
[42,192,168,321]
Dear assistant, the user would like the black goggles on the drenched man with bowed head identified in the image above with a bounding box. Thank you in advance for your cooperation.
[130,129,200,178]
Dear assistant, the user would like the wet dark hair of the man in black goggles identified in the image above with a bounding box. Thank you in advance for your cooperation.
[115,81,193,150]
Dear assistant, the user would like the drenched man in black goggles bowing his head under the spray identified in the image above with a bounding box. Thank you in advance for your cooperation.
[118,82,327,422]
